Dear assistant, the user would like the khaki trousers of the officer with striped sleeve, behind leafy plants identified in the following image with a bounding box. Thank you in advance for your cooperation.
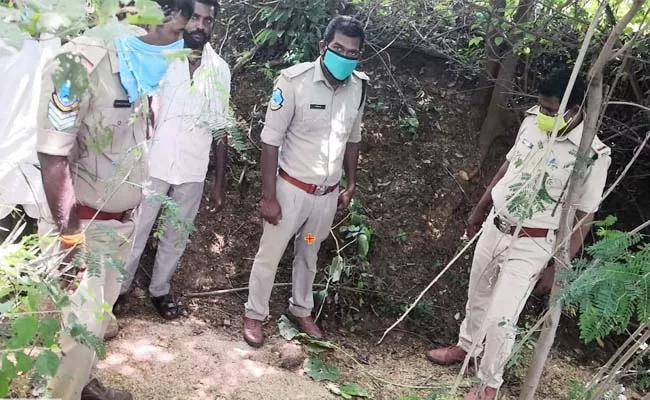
[48,220,135,400]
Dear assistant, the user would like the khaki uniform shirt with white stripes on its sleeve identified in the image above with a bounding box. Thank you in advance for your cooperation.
[37,37,148,212]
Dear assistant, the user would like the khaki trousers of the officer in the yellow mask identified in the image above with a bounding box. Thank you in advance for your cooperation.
[458,214,555,388]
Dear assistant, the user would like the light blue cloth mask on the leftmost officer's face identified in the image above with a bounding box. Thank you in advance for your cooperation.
[115,36,185,103]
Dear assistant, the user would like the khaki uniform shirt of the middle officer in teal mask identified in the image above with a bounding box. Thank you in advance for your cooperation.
[262,58,368,186]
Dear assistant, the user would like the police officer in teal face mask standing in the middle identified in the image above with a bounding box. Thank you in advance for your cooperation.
[244,16,368,347]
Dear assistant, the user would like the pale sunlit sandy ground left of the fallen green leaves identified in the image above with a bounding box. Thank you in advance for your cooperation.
[98,318,335,400]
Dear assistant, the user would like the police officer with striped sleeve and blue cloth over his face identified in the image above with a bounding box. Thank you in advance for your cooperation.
[37,0,193,400]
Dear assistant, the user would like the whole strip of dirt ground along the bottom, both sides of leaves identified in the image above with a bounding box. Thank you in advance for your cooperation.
[93,315,592,400]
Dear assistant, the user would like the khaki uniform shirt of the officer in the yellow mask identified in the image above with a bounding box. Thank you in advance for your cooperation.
[492,107,611,229]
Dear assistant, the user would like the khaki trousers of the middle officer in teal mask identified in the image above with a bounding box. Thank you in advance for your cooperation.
[245,177,339,320]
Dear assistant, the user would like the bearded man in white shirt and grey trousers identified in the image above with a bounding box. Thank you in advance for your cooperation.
[118,0,230,319]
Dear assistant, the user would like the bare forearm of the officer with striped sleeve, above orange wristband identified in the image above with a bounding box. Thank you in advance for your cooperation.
[38,153,81,235]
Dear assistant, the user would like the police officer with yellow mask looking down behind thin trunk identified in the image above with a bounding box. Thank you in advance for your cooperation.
[427,70,610,400]
